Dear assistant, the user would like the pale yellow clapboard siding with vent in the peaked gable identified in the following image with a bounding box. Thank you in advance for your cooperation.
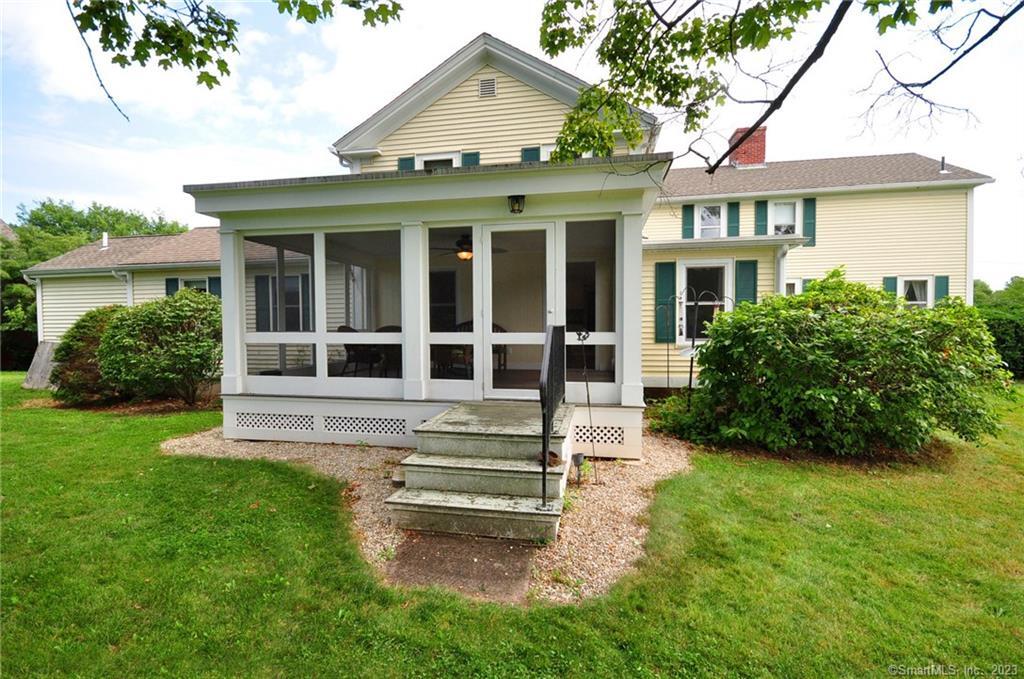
[361,66,569,172]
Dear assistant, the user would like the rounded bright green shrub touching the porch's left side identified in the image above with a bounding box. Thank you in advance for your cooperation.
[98,290,221,406]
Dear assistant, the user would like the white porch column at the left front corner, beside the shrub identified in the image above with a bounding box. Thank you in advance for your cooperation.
[220,234,246,394]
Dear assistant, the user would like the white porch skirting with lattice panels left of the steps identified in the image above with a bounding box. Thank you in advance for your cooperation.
[223,395,451,447]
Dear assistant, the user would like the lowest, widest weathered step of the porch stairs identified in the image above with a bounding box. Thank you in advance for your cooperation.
[385,487,562,541]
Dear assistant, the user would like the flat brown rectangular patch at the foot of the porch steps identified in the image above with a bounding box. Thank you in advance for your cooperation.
[385,531,537,603]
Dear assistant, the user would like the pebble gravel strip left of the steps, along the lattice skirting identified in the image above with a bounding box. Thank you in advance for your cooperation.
[161,427,411,567]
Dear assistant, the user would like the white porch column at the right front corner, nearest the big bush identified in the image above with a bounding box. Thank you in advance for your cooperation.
[618,212,644,406]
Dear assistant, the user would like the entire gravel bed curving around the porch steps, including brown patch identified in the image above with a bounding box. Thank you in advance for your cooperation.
[163,428,689,602]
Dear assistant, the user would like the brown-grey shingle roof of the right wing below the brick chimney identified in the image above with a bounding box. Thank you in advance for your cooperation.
[664,154,991,198]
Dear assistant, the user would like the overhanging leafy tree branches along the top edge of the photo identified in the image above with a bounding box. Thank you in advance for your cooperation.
[66,0,1024,173]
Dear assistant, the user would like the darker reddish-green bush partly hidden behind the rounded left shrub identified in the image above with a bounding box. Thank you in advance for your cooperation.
[50,304,124,405]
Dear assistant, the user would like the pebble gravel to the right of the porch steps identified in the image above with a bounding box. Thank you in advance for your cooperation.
[534,432,690,602]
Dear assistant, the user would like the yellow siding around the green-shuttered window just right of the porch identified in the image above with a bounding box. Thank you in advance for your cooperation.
[641,247,775,386]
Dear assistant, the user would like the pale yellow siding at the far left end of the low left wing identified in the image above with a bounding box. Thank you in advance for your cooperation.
[40,273,128,341]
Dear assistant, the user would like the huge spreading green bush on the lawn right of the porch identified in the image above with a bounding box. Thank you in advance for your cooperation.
[652,270,1009,456]
